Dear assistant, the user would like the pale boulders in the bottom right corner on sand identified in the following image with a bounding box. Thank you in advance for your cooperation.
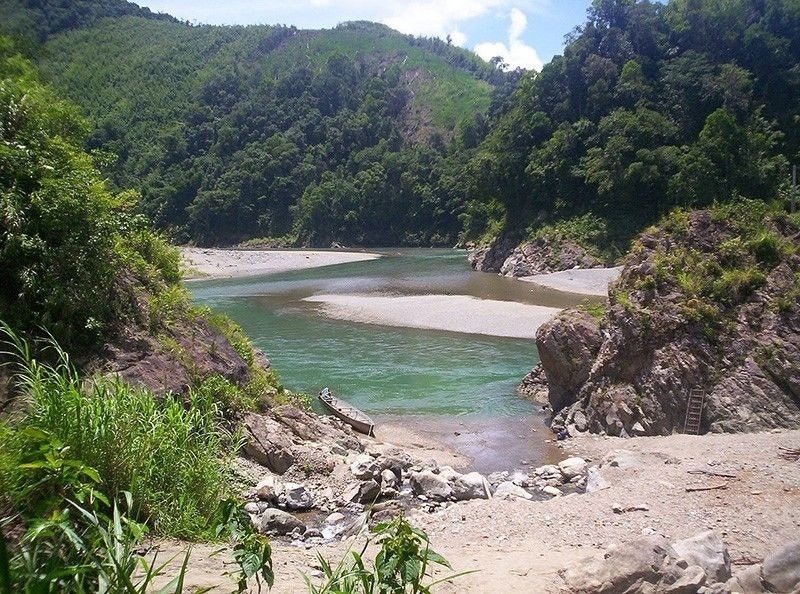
[562,531,800,594]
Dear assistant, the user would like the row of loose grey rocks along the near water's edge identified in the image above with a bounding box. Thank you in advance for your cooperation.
[245,440,588,544]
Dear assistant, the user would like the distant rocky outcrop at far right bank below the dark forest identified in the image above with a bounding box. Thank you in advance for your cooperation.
[468,237,605,277]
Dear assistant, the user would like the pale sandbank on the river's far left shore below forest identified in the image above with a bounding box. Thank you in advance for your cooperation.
[181,248,380,278]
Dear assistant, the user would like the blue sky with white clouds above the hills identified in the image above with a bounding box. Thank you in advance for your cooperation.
[138,0,591,70]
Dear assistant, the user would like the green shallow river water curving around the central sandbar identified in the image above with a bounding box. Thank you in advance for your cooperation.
[189,250,580,470]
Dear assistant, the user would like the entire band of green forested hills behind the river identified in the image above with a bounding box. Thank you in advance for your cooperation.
[3,0,800,251]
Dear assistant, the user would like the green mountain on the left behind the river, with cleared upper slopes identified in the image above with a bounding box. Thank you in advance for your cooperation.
[1,1,506,245]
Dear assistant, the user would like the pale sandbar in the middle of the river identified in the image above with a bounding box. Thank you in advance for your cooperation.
[304,295,561,338]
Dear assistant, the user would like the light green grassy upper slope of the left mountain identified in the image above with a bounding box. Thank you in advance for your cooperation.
[40,17,491,141]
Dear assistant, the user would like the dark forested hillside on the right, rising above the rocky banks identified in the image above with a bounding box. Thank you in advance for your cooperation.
[467,0,800,249]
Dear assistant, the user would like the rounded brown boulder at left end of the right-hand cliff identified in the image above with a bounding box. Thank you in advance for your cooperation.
[536,310,602,412]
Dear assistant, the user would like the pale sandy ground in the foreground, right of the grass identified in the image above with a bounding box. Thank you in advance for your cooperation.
[155,431,800,593]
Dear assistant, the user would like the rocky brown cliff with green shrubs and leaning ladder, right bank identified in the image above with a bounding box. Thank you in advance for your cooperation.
[537,204,800,435]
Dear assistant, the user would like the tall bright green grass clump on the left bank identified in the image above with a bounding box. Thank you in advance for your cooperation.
[0,328,237,539]
